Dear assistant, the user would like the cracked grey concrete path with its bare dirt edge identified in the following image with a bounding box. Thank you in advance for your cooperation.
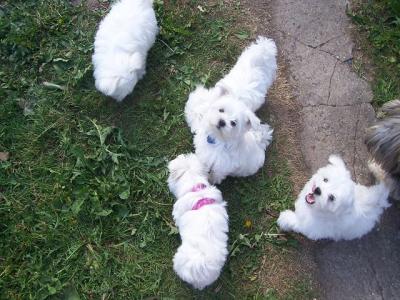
[244,0,400,299]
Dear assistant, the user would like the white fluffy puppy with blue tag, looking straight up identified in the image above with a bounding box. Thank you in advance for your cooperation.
[194,94,273,184]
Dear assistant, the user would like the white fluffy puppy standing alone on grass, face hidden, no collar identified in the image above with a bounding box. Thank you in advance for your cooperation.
[92,0,158,101]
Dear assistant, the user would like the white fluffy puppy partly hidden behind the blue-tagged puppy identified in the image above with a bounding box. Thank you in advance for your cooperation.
[185,37,277,132]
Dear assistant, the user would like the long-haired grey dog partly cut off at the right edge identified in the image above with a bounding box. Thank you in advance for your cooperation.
[365,100,400,199]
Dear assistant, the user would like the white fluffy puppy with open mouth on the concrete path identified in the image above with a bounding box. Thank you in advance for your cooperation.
[278,155,390,240]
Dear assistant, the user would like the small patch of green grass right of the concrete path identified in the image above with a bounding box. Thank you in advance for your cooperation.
[350,0,400,106]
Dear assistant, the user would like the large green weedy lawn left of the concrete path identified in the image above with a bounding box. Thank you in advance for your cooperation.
[0,0,308,299]
